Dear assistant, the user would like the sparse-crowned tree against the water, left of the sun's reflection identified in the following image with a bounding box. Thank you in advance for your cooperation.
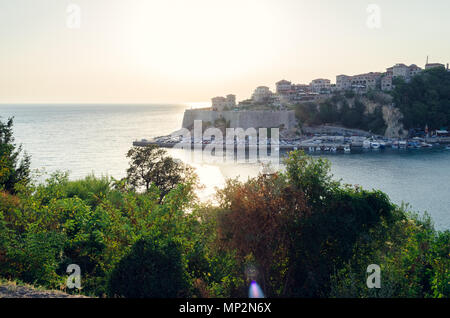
[127,145,197,201]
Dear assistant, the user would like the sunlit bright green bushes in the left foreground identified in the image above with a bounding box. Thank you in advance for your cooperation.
[0,168,200,296]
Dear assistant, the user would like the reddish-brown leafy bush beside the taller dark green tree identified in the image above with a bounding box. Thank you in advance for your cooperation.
[217,174,309,296]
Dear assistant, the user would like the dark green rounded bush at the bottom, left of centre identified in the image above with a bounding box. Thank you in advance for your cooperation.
[108,237,189,298]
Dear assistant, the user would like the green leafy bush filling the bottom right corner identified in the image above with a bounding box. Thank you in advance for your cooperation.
[330,207,450,298]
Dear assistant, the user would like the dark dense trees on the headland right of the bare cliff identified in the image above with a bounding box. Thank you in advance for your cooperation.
[393,68,450,130]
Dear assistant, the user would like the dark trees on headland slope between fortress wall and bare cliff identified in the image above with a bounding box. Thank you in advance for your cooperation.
[295,92,387,135]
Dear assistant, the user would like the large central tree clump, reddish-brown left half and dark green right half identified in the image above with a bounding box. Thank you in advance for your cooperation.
[217,151,394,297]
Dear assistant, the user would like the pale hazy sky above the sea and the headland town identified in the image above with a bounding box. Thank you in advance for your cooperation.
[0,0,450,103]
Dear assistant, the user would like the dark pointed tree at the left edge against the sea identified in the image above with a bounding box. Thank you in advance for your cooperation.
[0,118,31,194]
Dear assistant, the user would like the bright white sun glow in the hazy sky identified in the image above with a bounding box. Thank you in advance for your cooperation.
[116,0,290,83]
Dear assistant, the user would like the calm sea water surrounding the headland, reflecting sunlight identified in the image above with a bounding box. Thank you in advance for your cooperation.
[0,105,450,229]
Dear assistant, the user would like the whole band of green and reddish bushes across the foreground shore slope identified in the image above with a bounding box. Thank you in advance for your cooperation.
[0,117,450,297]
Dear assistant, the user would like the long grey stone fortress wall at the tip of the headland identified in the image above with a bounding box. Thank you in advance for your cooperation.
[183,109,297,130]
